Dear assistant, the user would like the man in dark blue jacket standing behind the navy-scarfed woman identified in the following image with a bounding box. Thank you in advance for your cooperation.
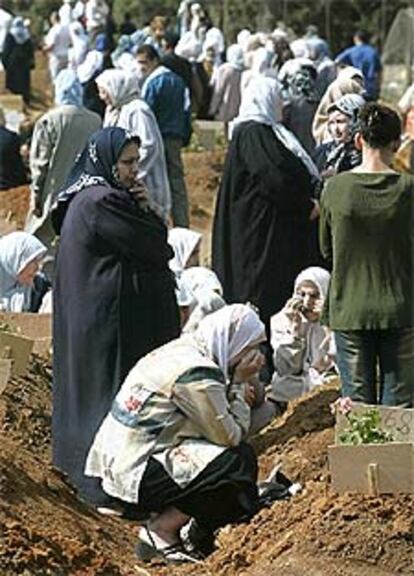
[136,44,191,228]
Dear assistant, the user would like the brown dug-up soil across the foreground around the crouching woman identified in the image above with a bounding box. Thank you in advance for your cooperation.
[0,357,414,576]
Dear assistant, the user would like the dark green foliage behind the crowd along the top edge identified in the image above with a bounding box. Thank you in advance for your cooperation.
[4,0,414,53]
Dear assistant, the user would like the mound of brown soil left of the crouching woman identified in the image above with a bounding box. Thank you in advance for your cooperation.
[0,357,136,576]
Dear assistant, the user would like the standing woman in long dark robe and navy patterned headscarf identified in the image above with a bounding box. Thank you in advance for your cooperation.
[53,128,179,506]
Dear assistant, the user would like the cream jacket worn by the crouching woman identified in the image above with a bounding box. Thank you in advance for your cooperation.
[85,335,250,502]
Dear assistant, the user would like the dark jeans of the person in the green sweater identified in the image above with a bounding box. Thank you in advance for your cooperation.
[335,328,414,408]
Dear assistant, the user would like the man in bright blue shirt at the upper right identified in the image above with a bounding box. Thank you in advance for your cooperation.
[335,30,381,100]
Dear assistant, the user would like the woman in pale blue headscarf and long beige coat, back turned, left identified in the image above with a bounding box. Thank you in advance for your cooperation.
[26,69,101,277]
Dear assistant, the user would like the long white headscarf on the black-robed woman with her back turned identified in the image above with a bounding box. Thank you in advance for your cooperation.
[231,76,319,179]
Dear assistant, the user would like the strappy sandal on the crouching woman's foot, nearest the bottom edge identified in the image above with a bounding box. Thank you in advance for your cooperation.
[135,526,200,564]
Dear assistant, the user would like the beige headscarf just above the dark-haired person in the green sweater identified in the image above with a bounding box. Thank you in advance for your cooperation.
[312,66,364,144]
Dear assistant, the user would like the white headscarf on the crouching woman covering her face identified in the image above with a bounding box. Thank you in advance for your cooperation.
[195,304,266,378]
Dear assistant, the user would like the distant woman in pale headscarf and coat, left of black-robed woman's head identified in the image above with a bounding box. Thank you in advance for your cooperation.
[210,44,244,129]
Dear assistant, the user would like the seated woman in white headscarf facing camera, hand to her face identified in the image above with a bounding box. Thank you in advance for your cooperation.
[270,266,334,402]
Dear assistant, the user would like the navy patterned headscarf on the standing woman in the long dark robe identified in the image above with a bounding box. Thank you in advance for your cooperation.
[52,127,141,233]
